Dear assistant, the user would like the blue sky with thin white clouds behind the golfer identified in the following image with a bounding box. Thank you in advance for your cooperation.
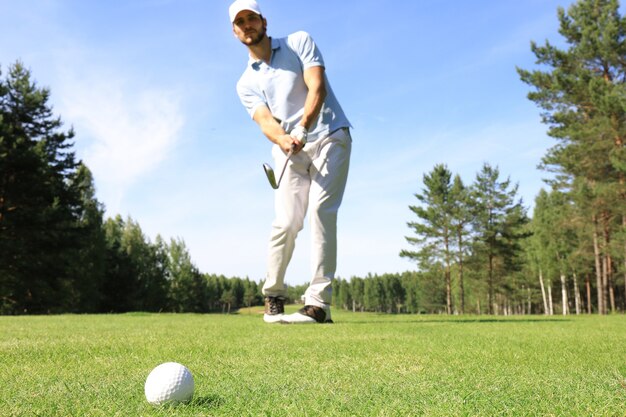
[0,0,584,284]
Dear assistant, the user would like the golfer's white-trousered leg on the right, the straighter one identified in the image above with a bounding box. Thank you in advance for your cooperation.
[305,129,352,307]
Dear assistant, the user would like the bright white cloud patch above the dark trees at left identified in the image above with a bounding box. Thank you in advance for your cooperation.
[60,75,184,213]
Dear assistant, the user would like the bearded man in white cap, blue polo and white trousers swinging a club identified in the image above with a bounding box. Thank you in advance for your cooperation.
[229,0,352,323]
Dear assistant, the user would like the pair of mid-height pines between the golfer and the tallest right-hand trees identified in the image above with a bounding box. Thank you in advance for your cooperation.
[400,164,529,314]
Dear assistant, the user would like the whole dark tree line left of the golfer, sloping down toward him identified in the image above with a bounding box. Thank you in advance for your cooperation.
[0,62,276,314]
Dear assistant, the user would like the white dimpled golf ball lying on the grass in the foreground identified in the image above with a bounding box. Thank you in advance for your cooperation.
[144,362,194,405]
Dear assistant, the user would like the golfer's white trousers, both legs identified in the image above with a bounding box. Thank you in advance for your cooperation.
[262,129,352,307]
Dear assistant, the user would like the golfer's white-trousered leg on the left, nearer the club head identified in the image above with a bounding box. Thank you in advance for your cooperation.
[262,146,310,297]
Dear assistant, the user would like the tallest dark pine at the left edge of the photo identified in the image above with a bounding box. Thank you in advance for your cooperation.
[0,62,82,313]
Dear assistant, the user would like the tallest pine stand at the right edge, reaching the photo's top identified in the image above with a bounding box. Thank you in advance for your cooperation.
[518,0,626,314]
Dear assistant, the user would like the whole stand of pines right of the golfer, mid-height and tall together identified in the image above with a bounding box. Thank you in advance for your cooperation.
[394,0,626,314]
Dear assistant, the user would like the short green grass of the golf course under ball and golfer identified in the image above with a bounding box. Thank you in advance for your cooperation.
[0,307,626,417]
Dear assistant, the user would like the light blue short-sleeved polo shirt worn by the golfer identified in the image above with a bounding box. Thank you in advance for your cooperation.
[237,32,350,142]
